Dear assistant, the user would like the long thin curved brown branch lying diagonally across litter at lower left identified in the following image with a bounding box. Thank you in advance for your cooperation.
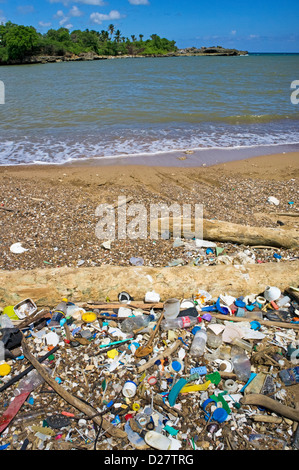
[22,336,127,438]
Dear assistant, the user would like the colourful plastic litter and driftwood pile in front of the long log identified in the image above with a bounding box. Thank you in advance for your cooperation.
[0,286,299,451]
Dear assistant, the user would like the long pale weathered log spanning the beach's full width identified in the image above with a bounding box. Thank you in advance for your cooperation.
[0,260,299,309]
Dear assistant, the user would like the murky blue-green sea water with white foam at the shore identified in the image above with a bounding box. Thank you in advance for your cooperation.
[0,54,299,165]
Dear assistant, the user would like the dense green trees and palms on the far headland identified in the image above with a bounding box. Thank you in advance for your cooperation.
[0,21,177,62]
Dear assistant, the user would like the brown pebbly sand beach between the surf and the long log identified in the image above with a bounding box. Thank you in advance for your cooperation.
[0,152,299,270]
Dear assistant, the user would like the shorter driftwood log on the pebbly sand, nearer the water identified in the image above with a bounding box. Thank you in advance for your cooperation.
[151,217,299,249]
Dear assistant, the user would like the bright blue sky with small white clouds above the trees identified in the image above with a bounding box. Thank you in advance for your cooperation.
[0,0,299,52]
